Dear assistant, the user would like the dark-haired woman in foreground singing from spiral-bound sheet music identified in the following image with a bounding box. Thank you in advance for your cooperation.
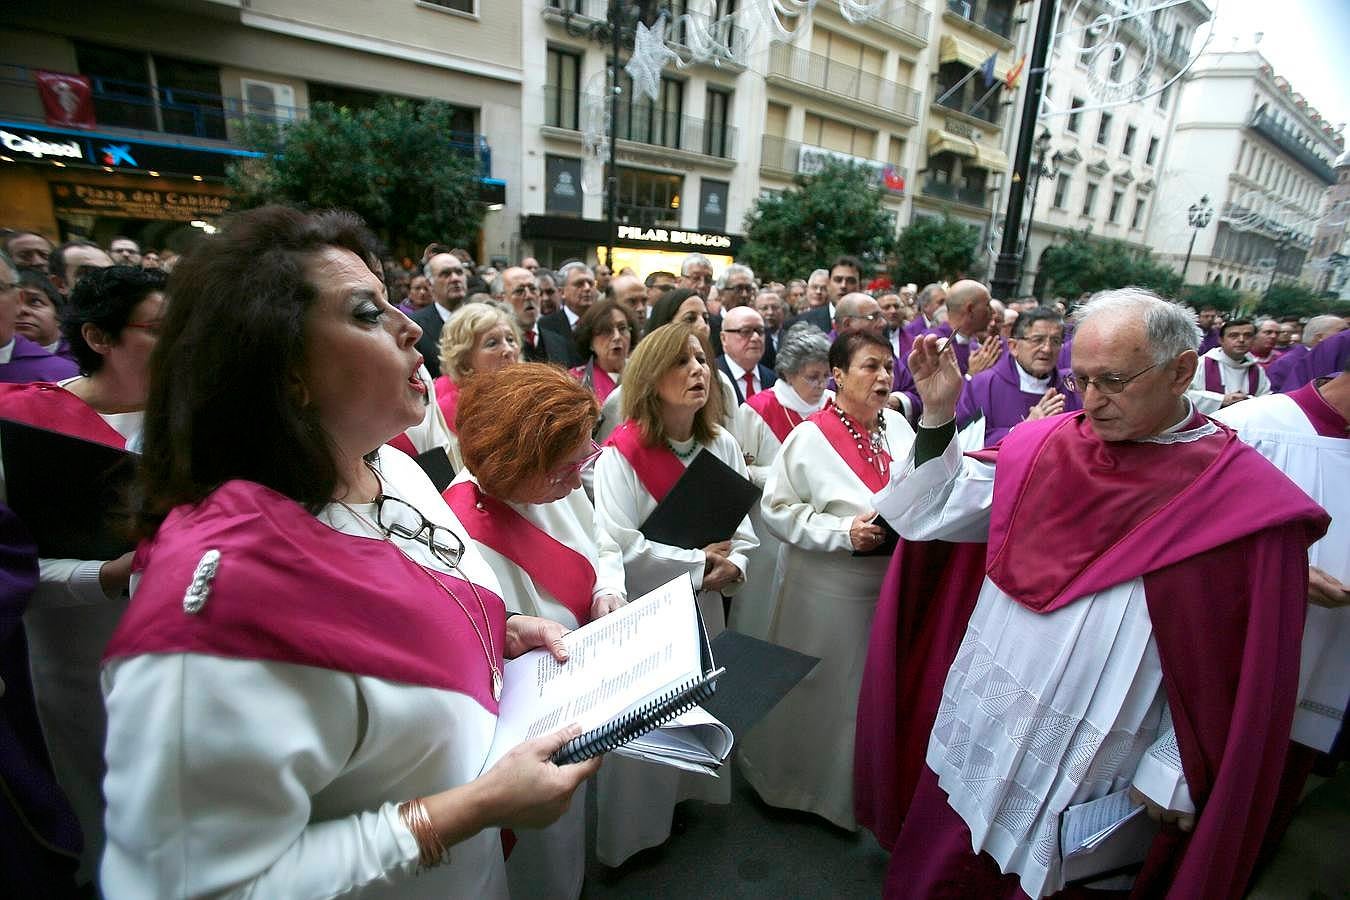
[101,206,597,900]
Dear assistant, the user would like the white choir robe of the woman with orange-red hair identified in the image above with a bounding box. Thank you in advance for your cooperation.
[454,470,625,900]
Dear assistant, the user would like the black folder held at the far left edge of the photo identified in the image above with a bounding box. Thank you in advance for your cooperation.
[0,420,136,560]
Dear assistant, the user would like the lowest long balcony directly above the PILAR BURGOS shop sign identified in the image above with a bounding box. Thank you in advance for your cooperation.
[544,85,737,159]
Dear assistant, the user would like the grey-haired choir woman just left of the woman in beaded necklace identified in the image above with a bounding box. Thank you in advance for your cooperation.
[728,322,834,638]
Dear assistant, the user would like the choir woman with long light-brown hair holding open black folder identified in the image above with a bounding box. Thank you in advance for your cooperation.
[595,324,759,866]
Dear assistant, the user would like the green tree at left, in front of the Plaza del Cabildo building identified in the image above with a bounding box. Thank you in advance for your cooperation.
[228,99,485,255]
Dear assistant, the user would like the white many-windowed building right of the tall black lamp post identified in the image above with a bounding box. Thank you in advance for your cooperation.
[1018,0,1211,296]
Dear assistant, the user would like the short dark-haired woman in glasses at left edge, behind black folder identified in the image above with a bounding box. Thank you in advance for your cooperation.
[0,266,165,882]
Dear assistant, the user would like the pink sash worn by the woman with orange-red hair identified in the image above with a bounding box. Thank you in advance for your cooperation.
[443,482,595,625]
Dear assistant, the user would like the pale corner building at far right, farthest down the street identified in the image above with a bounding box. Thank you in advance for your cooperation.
[1149,49,1345,291]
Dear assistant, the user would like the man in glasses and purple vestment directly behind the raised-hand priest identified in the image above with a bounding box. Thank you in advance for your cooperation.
[956,306,1083,447]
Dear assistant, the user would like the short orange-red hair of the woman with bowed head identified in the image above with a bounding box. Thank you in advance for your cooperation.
[455,363,599,499]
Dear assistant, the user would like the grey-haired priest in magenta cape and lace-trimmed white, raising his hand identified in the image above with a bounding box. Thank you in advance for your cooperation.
[856,289,1327,897]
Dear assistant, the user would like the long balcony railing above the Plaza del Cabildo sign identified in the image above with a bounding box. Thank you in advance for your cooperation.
[0,65,491,178]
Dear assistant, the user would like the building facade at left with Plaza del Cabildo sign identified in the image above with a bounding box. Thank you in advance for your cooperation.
[0,0,522,259]
